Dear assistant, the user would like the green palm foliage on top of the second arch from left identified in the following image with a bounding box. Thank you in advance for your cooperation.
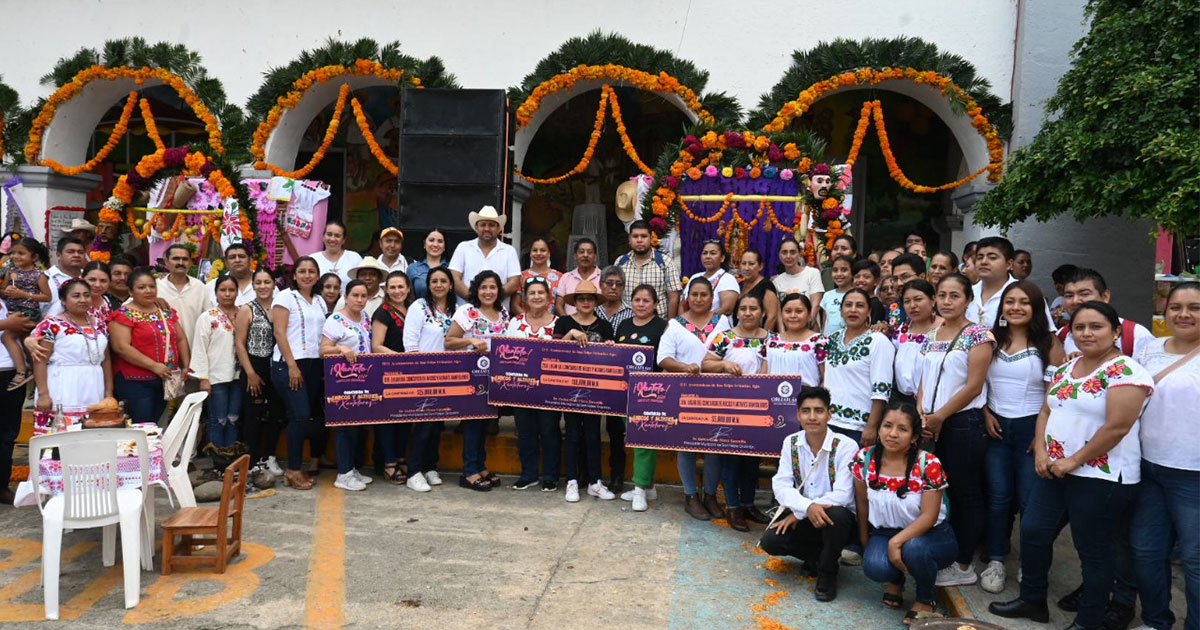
[246,37,460,120]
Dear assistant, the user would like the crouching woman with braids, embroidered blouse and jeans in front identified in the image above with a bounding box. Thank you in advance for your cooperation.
[850,403,959,624]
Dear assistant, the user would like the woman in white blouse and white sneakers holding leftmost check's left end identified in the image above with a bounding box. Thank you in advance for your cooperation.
[320,280,374,490]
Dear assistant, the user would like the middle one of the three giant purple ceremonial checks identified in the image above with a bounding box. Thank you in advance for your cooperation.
[487,337,654,415]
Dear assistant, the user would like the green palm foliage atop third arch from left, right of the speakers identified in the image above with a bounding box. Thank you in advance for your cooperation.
[509,30,742,126]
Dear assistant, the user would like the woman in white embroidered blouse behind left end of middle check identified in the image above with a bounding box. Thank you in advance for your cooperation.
[504,276,563,492]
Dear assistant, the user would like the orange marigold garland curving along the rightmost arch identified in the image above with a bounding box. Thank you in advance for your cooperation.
[763,67,1004,182]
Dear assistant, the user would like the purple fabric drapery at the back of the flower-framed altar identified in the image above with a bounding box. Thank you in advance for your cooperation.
[678,175,799,277]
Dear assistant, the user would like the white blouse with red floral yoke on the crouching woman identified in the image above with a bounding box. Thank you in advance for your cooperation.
[850,446,949,529]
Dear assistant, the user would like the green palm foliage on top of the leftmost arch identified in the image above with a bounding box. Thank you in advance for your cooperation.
[5,37,250,163]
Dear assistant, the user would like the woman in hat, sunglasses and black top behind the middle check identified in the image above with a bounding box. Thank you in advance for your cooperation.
[554,280,617,503]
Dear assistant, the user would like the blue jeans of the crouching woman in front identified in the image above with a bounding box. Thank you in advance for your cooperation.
[863,521,959,604]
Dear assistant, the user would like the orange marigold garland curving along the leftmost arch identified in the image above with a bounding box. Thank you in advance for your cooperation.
[25,66,224,166]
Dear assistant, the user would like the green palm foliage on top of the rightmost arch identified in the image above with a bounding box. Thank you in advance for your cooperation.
[746,37,1013,138]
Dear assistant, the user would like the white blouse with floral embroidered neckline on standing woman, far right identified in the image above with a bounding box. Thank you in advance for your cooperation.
[1043,356,1154,485]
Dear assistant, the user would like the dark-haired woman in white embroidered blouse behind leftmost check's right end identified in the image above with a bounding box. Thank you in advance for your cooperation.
[446,270,509,492]
